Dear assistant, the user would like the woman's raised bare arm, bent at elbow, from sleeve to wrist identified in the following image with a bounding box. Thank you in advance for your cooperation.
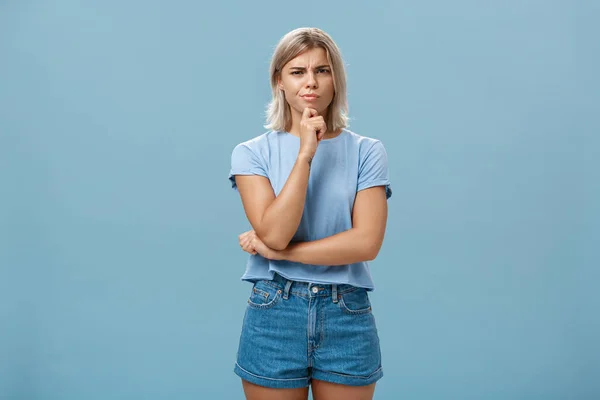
[235,153,312,250]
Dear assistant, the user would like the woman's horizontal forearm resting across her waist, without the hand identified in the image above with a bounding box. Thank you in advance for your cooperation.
[275,228,380,265]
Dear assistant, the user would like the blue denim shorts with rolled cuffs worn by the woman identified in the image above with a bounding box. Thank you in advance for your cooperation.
[234,274,383,388]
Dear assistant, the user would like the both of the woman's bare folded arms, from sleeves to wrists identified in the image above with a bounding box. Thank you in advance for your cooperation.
[235,156,388,265]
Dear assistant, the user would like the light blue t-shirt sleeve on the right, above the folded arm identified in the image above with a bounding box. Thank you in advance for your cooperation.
[356,140,392,199]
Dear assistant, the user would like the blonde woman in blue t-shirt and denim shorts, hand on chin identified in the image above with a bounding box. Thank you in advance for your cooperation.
[229,28,392,400]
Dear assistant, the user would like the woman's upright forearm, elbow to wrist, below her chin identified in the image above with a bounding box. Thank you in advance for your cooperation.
[256,153,312,250]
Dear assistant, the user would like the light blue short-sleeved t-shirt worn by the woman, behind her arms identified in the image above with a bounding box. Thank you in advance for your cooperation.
[229,129,392,290]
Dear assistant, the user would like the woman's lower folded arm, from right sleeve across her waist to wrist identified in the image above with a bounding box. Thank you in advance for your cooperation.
[274,186,388,265]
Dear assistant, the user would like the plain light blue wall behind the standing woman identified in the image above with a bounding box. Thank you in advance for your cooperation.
[0,0,600,400]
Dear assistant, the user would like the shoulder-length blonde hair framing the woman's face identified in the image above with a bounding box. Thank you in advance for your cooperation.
[264,28,348,132]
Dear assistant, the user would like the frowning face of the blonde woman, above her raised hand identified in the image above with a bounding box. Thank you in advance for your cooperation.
[278,47,334,116]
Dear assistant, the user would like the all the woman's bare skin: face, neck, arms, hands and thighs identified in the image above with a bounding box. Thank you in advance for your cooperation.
[236,48,388,400]
